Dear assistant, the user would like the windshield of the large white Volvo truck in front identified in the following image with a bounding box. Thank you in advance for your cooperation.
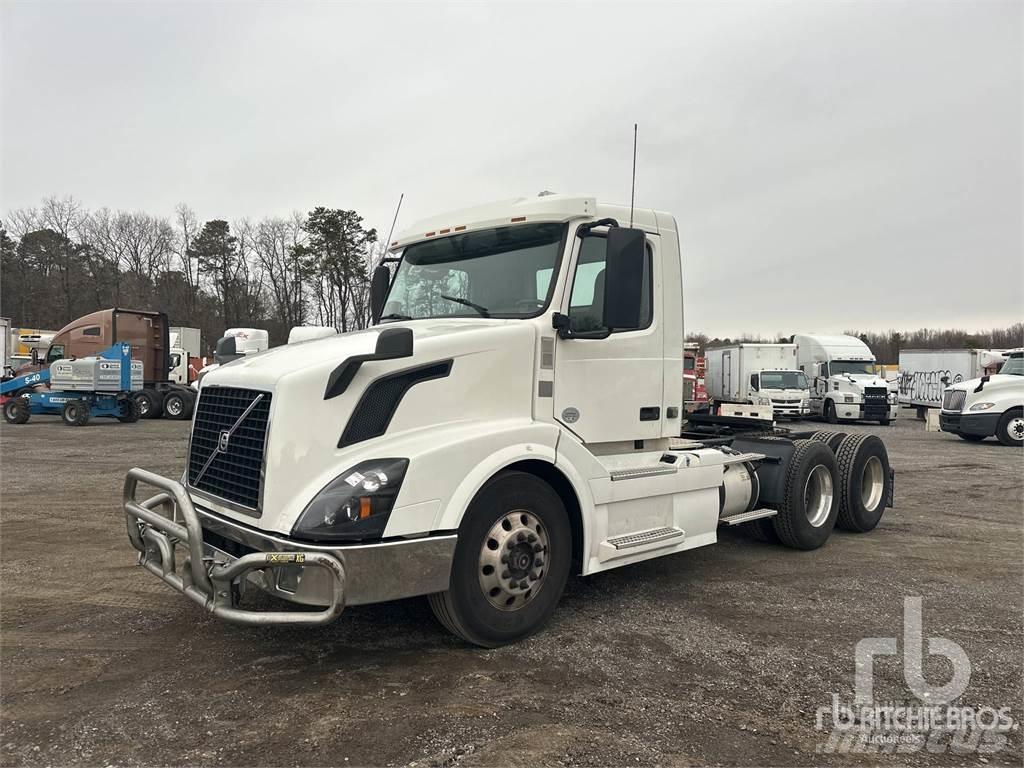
[381,224,565,321]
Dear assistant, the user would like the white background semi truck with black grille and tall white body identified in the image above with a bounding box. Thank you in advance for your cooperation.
[793,334,899,426]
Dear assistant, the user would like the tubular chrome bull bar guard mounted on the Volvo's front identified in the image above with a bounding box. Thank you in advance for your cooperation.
[123,468,345,627]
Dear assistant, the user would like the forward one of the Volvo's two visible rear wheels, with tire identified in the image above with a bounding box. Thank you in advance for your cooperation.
[771,440,839,550]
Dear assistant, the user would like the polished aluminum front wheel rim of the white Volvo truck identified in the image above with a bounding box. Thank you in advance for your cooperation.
[479,509,548,610]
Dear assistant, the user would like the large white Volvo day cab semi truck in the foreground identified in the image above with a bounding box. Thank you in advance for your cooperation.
[117,196,892,646]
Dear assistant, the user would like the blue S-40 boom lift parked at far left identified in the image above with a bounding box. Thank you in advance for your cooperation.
[0,344,138,427]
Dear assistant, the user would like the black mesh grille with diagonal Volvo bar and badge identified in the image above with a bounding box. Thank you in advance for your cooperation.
[188,387,270,510]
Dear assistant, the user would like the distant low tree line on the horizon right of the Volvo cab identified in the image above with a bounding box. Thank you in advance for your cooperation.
[686,323,1024,366]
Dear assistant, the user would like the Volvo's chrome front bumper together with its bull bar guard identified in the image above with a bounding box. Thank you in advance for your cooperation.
[123,469,456,627]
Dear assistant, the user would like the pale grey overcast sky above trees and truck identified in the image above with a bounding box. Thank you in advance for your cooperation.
[0,0,1024,336]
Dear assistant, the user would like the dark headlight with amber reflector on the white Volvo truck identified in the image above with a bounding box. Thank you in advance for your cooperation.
[292,459,409,542]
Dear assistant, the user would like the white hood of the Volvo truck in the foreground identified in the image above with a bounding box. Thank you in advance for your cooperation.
[194,317,537,535]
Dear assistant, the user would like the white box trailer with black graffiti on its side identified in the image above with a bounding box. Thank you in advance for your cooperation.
[898,349,1006,418]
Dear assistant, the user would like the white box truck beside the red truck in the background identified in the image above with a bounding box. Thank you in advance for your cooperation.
[705,343,810,419]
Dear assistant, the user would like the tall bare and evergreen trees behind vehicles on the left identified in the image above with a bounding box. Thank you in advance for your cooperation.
[0,198,384,351]
